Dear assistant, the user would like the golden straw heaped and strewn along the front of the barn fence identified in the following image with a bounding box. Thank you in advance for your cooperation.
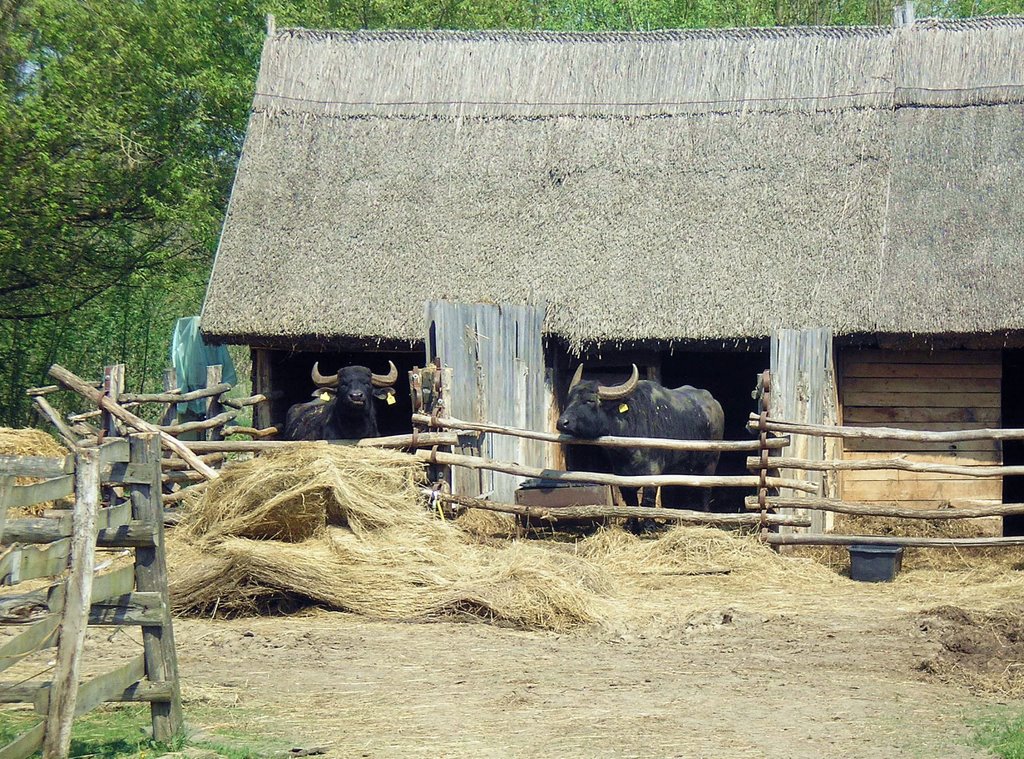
[169,444,1024,692]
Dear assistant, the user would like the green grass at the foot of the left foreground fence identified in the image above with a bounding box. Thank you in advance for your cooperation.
[0,705,283,759]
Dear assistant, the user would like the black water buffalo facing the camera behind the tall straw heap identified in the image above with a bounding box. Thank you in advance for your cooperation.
[285,362,398,440]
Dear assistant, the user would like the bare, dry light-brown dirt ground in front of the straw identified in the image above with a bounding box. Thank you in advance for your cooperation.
[175,577,1017,759]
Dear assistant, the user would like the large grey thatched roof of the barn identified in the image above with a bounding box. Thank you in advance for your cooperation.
[203,18,1024,347]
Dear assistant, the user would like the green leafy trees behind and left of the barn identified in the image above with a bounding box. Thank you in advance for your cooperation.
[0,0,1024,426]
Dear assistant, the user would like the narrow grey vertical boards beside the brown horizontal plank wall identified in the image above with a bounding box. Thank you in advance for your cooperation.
[769,329,837,533]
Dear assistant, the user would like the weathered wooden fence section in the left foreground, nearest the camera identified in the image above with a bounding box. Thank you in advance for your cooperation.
[0,433,181,759]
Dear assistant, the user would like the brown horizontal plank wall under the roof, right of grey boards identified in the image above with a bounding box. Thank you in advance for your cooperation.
[840,349,1002,508]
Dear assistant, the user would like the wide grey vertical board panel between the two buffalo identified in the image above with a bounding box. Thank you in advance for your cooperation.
[426,302,551,503]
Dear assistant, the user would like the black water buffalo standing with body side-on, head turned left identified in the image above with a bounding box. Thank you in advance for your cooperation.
[557,364,725,529]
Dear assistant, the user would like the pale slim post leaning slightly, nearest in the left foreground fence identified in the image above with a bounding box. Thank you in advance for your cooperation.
[43,449,99,759]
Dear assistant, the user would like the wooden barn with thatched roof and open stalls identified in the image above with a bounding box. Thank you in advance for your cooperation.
[202,18,1024,528]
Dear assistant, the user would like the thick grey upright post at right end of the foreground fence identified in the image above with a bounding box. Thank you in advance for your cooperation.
[129,433,181,742]
